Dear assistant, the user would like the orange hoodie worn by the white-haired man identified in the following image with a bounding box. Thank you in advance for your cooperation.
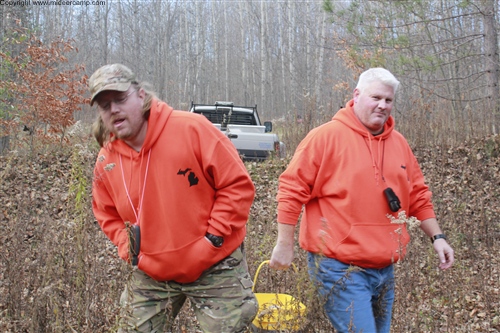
[277,100,435,268]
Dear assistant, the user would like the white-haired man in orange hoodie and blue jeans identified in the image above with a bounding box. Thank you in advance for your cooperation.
[270,68,454,333]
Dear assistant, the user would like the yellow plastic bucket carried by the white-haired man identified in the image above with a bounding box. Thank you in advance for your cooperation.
[252,260,306,331]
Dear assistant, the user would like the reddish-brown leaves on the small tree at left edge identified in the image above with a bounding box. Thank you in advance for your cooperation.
[0,34,87,147]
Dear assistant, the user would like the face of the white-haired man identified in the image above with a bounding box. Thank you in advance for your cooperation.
[354,82,394,135]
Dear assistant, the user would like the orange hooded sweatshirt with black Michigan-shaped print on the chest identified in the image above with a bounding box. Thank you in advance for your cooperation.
[92,99,255,283]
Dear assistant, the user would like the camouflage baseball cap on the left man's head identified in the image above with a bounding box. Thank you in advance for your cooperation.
[89,64,137,105]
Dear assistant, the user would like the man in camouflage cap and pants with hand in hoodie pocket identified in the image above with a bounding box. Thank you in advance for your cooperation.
[89,64,257,333]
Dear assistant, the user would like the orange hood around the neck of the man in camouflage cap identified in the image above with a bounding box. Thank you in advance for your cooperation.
[108,98,173,156]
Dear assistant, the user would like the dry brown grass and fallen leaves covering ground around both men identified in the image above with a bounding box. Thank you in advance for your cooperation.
[0,125,500,333]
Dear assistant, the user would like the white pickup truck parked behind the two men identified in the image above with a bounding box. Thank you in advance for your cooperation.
[189,102,285,161]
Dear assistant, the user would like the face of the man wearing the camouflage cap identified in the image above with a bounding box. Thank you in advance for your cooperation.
[96,86,147,144]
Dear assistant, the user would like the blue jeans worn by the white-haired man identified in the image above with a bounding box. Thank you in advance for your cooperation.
[307,253,394,333]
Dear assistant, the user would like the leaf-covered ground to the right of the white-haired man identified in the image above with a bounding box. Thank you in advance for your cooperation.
[393,136,500,332]
